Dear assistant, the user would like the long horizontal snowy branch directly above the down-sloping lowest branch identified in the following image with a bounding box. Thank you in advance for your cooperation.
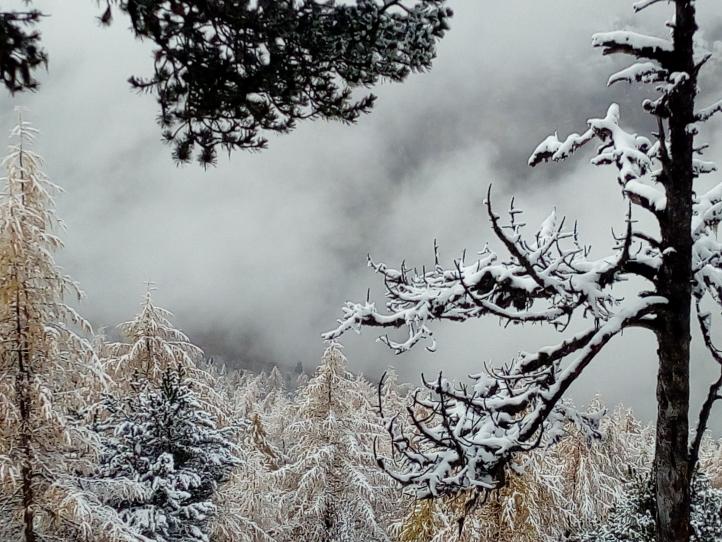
[324,191,657,353]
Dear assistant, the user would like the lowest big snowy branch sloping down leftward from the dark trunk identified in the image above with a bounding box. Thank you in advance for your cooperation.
[381,297,666,498]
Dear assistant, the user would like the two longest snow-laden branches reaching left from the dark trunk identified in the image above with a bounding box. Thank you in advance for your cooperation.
[324,186,666,497]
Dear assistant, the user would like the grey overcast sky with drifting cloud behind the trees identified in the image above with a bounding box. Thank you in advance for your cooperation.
[0,0,722,424]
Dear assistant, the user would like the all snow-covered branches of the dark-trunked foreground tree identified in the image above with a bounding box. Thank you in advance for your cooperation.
[324,0,722,520]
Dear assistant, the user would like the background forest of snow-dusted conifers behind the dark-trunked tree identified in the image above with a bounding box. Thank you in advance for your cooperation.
[0,112,722,542]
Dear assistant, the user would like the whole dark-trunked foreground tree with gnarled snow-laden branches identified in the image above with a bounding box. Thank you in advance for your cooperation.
[325,0,722,542]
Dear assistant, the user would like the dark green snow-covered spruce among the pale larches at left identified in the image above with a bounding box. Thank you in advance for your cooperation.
[98,368,238,542]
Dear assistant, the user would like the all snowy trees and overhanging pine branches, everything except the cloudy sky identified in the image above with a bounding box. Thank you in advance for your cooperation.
[0,0,722,542]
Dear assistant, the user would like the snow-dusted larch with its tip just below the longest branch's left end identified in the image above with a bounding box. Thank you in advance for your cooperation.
[276,345,394,542]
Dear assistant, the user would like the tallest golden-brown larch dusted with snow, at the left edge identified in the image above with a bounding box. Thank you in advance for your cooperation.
[0,112,129,542]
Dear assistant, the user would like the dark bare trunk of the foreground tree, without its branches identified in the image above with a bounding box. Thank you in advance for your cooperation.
[654,0,697,542]
